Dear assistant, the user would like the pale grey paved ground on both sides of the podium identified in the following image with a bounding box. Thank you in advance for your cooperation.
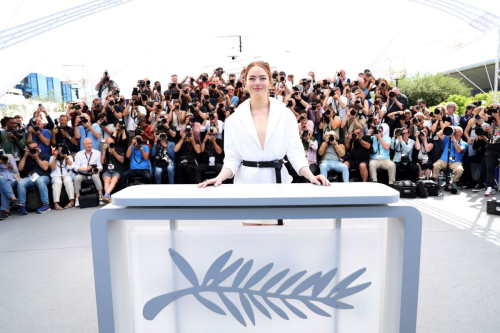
[0,187,500,333]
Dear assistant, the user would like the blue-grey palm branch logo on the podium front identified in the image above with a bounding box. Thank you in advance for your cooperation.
[143,249,371,326]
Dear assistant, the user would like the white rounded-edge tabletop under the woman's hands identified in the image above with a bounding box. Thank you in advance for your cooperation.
[112,183,399,208]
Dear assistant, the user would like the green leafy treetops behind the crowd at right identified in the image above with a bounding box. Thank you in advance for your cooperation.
[399,73,471,106]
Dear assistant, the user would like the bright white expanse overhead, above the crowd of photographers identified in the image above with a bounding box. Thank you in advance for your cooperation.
[0,0,500,97]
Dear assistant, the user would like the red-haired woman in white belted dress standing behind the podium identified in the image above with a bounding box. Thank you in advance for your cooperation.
[198,61,330,223]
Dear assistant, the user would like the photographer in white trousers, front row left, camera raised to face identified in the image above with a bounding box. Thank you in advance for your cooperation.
[49,144,75,210]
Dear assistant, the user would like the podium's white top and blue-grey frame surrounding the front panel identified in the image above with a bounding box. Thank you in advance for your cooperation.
[91,183,422,333]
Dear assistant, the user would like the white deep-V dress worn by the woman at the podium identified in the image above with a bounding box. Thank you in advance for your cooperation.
[223,98,309,184]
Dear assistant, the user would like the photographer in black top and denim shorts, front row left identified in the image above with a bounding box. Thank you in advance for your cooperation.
[101,138,126,203]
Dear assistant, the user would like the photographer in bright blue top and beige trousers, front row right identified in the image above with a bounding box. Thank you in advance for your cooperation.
[432,126,467,191]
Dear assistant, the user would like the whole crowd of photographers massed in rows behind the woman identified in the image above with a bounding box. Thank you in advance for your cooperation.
[0,68,500,219]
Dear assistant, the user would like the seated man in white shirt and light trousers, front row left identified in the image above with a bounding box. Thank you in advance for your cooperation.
[73,138,104,207]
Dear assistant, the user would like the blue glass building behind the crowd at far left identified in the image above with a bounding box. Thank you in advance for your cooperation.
[15,73,76,102]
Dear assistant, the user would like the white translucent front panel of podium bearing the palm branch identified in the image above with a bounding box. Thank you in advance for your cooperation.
[130,227,384,333]
